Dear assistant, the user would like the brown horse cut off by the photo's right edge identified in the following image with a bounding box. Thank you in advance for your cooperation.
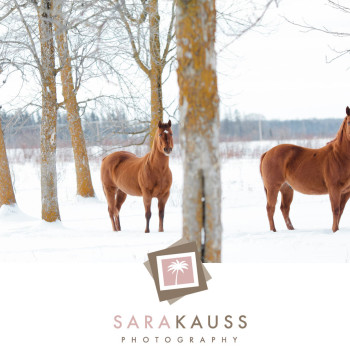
[260,107,350,232]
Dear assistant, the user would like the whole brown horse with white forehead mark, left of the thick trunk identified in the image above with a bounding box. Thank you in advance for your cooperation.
[101,120,173,233]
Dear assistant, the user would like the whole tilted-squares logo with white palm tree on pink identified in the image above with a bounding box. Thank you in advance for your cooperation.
[145,240,211,304]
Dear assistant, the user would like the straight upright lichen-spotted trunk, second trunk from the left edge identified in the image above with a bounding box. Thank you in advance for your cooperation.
[38,0,60,222]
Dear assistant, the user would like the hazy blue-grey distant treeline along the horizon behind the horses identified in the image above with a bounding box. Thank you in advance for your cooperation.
[0,111,342,148]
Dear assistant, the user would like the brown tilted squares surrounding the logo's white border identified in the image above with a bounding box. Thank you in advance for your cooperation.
[145,241,211,303]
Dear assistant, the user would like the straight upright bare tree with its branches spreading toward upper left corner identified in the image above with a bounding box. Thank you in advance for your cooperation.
[1,0,60,222]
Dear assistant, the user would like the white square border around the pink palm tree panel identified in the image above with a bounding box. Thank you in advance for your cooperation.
[157,252,199,291]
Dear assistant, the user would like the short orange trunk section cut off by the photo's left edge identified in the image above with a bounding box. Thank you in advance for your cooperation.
[0,121,16,207]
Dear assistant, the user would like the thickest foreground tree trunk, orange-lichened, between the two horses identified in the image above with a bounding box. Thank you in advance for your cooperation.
[176,0,222,262]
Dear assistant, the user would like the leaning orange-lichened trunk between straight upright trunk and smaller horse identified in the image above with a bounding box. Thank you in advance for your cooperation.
[55,9,95,197]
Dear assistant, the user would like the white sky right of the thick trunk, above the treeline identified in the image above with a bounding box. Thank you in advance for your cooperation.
[219,0,350,119]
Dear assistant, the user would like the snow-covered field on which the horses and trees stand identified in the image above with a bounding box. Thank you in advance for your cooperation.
[0,140,350,263]
